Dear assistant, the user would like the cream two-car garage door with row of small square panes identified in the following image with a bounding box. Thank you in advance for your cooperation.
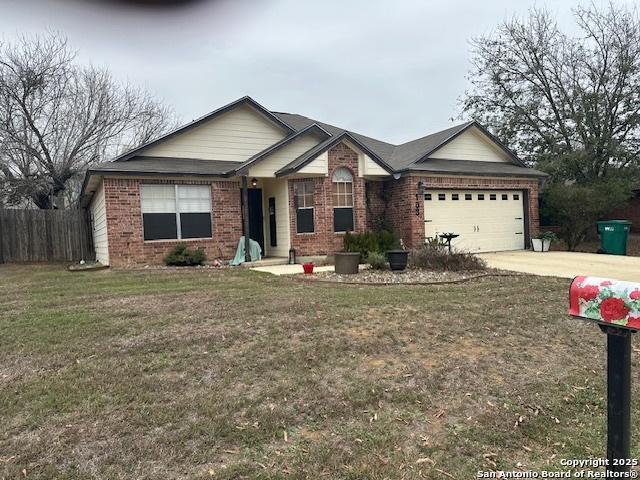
[424,190,524,252]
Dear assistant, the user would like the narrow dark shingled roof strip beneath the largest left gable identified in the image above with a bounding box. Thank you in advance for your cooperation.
[88,157,243,177]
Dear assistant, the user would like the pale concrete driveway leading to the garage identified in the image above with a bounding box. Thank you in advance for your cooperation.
[478,250,640,282]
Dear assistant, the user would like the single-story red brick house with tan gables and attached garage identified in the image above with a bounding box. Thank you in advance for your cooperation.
[81,97,545,267]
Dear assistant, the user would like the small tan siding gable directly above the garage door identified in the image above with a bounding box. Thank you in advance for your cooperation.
[429,127,511,163]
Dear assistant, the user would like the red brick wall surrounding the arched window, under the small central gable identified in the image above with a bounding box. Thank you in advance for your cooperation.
[289,143,368,255]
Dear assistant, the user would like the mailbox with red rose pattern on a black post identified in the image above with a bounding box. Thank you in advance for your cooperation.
[569,277,640,472]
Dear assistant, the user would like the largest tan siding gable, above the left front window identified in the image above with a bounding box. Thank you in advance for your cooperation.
[144,105,285,162]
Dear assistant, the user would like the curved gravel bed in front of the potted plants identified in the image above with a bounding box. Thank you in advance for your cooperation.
[304,270,495,284]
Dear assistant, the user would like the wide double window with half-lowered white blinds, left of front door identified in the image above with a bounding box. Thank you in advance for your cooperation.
[140,184,212,240]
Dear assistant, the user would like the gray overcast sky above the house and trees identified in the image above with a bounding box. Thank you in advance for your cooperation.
[0,0,632,143]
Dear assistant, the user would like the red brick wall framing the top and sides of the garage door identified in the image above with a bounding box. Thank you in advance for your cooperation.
[387,175,540,248]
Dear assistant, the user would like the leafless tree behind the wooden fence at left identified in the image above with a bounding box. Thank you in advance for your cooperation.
[0,34,173,208]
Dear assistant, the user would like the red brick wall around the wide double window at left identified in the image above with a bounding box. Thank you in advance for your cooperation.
[104,178,242,267]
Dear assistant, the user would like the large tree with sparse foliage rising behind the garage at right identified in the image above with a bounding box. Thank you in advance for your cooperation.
[461,4,640,183]
